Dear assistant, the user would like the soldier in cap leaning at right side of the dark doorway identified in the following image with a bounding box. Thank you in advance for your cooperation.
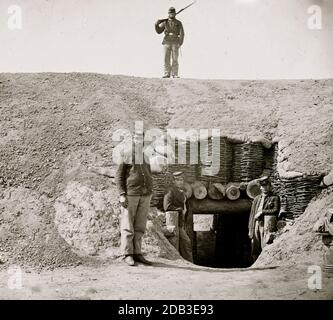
[249,176,280,261]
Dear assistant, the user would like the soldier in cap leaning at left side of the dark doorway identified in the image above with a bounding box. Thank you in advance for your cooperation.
[163,171,193,262]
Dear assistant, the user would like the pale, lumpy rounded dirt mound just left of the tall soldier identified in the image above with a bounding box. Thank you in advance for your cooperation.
[54,182,120,255]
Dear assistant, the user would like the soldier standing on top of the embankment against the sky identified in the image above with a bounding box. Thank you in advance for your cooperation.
[155,7,184,78]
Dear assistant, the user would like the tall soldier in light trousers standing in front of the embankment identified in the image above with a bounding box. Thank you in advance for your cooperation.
[116,132,152,266]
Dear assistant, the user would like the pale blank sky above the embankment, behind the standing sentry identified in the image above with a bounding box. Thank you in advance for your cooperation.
[0,0,333,79]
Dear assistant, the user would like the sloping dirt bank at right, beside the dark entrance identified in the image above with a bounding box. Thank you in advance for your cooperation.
[254,187,333,267]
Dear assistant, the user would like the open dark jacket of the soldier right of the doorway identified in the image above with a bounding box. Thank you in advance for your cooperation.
[249,192,280,239]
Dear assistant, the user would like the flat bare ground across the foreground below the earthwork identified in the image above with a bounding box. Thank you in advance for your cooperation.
[0,259,333,300]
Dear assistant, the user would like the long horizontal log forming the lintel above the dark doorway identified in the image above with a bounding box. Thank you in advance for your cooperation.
[189,198,252,214]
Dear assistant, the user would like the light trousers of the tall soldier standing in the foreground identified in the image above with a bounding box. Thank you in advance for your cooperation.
[120,195,151,255]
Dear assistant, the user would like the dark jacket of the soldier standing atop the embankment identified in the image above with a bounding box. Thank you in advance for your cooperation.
[155,19,184,46]
